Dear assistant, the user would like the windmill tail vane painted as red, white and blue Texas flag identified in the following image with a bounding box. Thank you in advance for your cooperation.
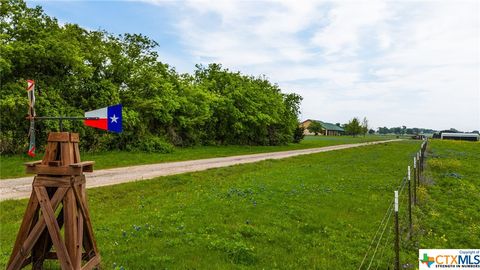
[84,104,122,133]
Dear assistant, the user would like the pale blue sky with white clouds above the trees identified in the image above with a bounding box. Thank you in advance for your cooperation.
[27,0,480,131]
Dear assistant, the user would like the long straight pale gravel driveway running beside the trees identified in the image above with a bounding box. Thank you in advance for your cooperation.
[0,139,400,201]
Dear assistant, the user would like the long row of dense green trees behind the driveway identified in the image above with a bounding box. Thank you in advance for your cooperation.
[0,0,302,154]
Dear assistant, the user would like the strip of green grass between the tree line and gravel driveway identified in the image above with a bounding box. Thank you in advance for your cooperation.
[0,136,395,179]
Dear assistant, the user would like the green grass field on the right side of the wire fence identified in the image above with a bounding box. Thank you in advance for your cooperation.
[410,140,480,262]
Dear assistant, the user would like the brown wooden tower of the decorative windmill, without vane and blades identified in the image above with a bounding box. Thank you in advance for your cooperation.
[7,132,100,270]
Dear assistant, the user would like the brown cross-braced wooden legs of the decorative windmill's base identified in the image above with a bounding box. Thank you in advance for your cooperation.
[7,175,100,270]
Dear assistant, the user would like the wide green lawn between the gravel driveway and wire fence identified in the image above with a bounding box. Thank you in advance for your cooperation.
[0,141,420,269]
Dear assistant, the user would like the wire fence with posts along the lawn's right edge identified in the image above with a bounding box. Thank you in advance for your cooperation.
[358,140,428,270]
